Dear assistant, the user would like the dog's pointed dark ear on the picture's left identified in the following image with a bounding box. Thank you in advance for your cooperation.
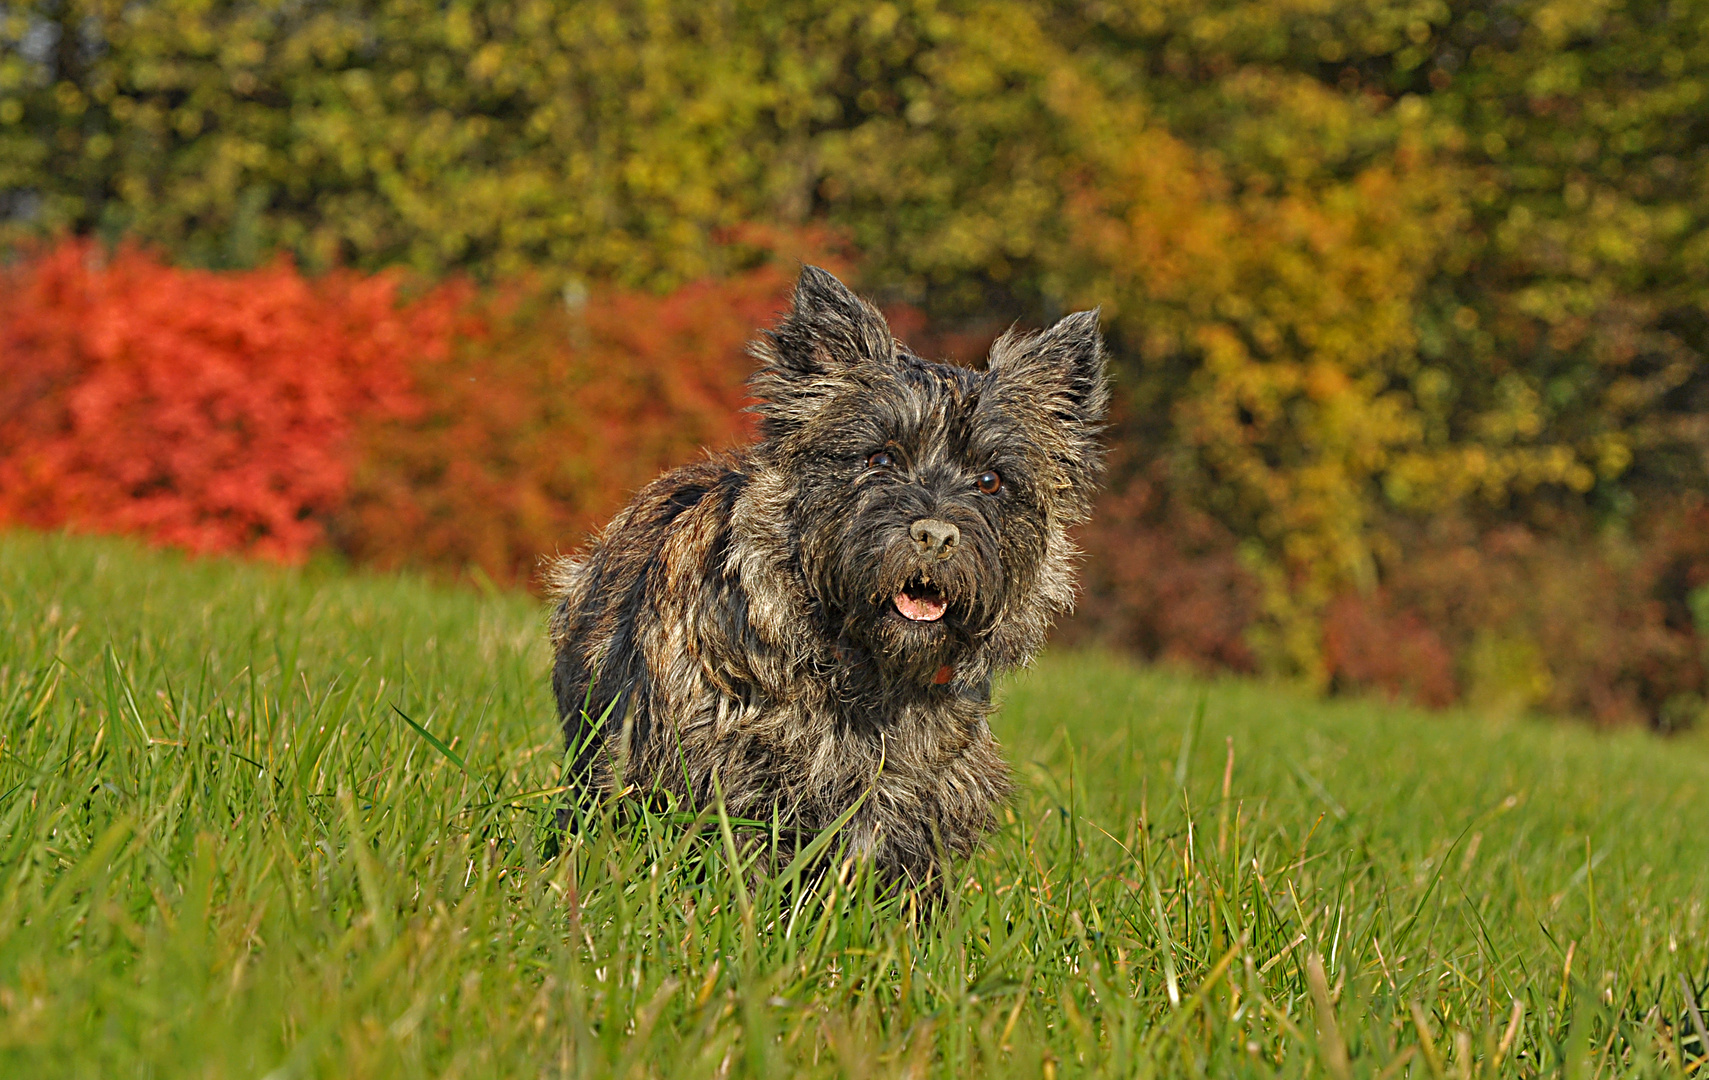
[749,267,896,439]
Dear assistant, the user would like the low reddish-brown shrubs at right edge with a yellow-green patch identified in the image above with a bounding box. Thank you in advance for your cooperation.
[1324,496,1709,728]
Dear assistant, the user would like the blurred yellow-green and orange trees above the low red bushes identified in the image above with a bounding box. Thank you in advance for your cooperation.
[0,0,1709,700]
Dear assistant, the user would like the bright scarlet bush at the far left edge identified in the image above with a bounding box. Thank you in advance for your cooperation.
[0,241,456,561]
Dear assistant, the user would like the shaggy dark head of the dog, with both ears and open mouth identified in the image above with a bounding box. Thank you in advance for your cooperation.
[750,267,1109,682]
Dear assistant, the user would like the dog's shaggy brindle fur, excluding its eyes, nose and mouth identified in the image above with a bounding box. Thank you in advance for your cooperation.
[552,268,1109,882]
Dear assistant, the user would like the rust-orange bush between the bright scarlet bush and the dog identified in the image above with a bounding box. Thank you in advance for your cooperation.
[333,263,793,581]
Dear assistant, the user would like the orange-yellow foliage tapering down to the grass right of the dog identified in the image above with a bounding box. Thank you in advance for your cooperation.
[1070,116,1456,682]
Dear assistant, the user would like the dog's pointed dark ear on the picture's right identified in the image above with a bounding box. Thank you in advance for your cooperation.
[988,309,1109,425]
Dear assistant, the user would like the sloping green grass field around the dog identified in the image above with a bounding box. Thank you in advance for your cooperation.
[0,533,1709,1078]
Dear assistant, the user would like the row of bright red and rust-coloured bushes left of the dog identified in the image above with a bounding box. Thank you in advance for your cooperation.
[0,241,791,583]
